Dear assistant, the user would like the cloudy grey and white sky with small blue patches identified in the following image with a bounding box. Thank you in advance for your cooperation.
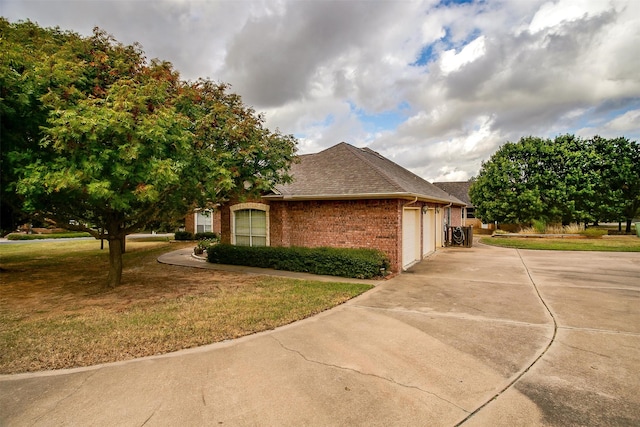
[0,0,640,182]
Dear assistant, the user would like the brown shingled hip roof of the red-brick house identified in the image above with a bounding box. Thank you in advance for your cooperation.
[266,142,464,205]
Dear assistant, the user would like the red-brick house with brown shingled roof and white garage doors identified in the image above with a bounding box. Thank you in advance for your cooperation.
[187,142,465,272]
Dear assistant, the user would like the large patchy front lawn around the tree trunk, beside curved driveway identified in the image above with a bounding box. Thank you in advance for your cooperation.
[0,240,370,374]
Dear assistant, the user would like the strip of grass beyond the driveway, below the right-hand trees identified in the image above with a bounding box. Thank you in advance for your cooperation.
[480,236,640,252]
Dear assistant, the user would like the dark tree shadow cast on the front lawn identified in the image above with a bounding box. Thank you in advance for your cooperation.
[0,243,254,317]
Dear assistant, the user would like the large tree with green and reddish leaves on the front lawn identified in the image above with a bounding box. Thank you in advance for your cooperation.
[1,23,296,287]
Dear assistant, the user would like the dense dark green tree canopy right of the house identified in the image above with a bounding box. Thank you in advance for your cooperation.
[470,135,640,232]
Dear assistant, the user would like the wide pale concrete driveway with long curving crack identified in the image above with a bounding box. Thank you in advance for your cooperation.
[0,245,640,426]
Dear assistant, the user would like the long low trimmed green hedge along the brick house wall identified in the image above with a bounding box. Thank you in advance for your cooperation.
[207,245,389,279]
